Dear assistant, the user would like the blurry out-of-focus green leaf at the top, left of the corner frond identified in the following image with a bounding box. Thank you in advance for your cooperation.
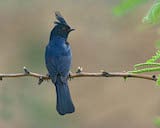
[113,0,148,16]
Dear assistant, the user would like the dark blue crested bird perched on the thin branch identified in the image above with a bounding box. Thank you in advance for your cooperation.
[45,11,75,115]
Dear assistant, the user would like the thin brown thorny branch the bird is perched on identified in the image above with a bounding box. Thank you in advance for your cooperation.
[0,67,157,84]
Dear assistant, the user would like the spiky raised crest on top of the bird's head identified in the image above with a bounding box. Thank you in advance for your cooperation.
[54,11,68,26]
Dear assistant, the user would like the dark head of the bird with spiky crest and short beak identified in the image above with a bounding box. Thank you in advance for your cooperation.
[50,12,75,40]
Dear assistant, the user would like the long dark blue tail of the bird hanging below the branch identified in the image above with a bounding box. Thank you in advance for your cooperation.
[55,77,75,115]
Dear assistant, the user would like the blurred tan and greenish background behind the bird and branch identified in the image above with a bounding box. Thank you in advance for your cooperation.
[0,0,160,128]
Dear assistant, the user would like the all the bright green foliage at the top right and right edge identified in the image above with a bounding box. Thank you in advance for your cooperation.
[113,0,160,127]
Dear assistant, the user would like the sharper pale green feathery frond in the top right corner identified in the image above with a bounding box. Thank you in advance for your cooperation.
[143,0,160,24]
